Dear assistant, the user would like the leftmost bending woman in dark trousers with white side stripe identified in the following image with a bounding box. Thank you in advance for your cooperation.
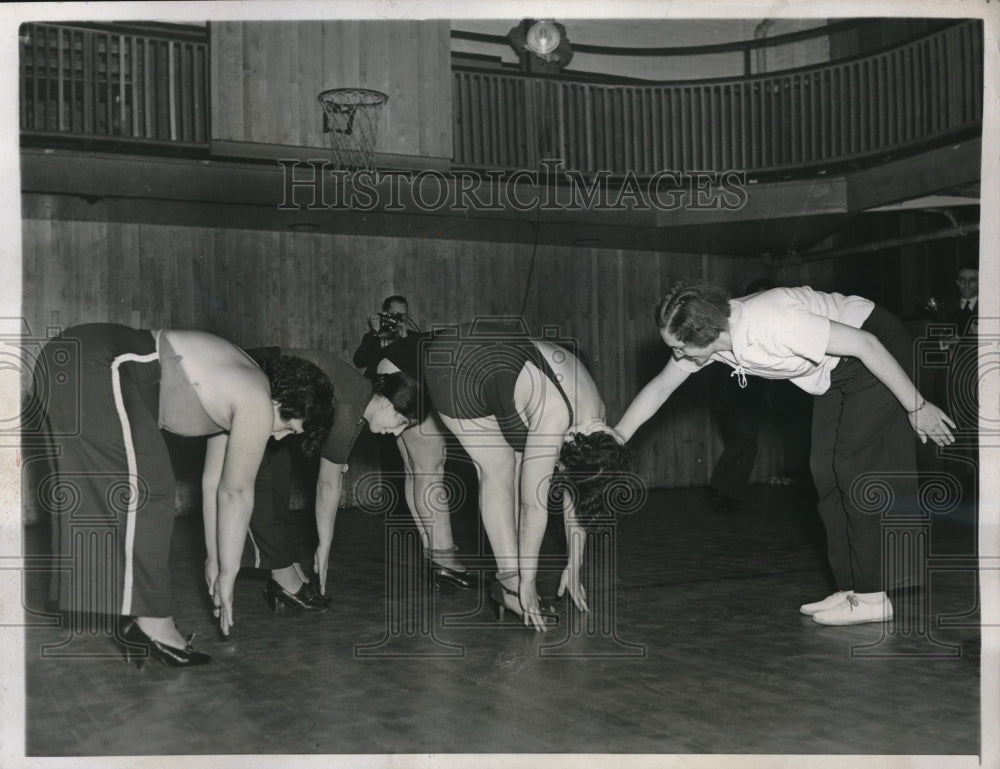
[36,324,331,666]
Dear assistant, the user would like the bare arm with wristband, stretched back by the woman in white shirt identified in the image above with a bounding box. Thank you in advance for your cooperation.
[826,321,955,446]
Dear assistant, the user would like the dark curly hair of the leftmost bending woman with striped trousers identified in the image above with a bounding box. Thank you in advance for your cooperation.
[261,355,333,456]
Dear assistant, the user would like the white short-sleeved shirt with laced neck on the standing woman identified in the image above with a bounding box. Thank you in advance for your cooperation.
[675,286,875,395]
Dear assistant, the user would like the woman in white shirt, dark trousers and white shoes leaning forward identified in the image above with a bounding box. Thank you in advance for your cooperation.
[616,281,955,625]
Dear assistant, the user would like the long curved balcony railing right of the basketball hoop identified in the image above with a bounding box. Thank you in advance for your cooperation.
[453,21,983,175]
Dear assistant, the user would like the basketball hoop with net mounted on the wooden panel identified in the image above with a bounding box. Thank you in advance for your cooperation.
[316,88,389,175]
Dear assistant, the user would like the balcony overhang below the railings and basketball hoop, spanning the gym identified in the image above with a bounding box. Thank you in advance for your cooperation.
[21,139,981,255]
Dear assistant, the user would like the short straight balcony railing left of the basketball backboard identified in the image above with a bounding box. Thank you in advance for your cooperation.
[20,24,209,146]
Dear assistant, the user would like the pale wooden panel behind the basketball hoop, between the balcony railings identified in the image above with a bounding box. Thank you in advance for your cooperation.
[210,20,452,158]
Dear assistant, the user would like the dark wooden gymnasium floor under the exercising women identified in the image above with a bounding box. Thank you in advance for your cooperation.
[19,486,980,756]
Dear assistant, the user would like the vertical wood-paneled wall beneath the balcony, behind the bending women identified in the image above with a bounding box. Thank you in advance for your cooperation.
[23,219,781,516]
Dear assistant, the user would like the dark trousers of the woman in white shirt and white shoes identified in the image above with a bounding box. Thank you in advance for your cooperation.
[810,307,919,593]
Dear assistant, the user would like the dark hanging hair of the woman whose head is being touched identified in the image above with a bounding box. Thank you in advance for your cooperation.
[552,432,631,526]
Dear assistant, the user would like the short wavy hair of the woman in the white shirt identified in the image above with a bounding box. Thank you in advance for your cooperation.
[656,279,731,347]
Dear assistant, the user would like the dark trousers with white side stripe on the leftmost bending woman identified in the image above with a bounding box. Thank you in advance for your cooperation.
[36,323,176,617]
